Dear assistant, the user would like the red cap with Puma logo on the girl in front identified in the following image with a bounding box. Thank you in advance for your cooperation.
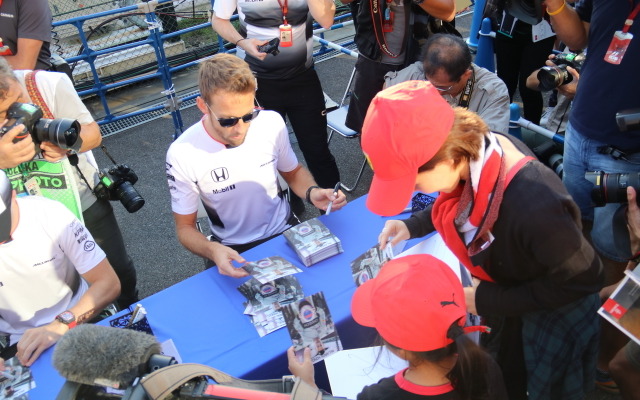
[351,254,466,351]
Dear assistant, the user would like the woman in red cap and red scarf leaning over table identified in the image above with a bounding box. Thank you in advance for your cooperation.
[362,81,602,400]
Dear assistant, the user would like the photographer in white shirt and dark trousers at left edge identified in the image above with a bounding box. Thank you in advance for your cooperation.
[0,57,138,308]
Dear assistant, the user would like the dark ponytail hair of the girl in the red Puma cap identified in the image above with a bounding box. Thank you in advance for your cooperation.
[376,321,490,400]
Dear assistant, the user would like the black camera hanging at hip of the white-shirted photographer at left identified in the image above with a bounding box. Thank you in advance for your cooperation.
[93,164,144,213]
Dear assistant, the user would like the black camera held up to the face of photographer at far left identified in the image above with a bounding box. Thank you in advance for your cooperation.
[0,102,82,152]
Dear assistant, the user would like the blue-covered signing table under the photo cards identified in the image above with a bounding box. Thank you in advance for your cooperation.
[29,196,416,400]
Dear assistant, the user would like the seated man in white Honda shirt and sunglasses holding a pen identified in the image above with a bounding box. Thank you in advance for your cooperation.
[166,54,346,277]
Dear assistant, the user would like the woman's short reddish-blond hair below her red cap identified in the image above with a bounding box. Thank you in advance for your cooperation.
[418,107,489,172]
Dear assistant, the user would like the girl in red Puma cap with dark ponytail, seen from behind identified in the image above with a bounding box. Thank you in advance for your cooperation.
[287,254,507,400]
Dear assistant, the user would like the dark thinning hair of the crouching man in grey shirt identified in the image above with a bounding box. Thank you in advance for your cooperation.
[420,33,471,82]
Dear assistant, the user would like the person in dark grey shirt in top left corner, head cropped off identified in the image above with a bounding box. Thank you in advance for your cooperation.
[0,0,51,70]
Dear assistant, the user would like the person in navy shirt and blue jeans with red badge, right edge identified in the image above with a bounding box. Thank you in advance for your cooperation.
[545,0,640,389]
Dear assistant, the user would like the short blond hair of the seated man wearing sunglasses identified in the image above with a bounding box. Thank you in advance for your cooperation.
[198,53,256,103]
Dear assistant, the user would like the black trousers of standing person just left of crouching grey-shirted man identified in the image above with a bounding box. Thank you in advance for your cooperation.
[345,56,402,132]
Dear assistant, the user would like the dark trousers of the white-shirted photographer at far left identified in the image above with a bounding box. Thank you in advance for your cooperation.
[82,199,138,309]
